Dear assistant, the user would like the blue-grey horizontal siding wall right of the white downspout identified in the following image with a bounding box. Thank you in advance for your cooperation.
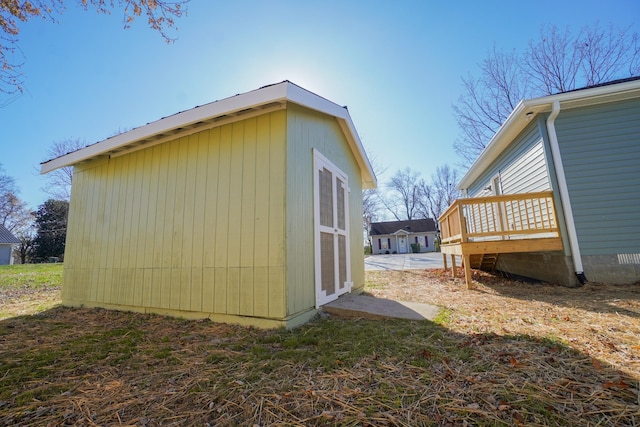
[556,99,640,256]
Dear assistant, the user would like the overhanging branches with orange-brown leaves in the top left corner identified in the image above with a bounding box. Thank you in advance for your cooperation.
[0,0,189,95]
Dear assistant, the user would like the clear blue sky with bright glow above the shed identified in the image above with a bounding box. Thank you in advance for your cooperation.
[0,0,640,208]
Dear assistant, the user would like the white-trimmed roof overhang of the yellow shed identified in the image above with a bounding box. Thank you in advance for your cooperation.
[40,80,377,188]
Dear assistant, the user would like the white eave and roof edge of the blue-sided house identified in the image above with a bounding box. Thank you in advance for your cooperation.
[456,77,640,190]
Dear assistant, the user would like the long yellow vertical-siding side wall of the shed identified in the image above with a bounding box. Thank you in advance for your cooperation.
[63,111,287,319]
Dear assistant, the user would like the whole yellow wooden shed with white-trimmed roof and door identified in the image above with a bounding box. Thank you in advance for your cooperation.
[41,81,376,327]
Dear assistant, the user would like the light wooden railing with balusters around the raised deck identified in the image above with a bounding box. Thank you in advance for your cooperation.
[439,191,559,246]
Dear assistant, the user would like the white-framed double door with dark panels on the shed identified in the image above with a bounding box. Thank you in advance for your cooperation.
[314,150,352,307]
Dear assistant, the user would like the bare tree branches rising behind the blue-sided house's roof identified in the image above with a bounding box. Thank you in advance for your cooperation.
[453,24,640,166]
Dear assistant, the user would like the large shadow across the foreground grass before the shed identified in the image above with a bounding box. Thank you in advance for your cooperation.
[0,307,640,426]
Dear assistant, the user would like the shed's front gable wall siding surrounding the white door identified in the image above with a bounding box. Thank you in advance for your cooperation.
[286,105,364,314]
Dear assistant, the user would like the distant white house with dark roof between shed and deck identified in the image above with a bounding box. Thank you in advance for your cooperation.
[369,218,436,254]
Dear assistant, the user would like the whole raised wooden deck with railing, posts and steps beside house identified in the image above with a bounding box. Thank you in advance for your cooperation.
[439,191,562,288]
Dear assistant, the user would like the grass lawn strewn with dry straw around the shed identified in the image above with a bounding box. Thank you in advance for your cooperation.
[0,265,640,426]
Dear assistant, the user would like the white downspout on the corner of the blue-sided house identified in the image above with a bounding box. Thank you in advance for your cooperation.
[547,101,587,285]
